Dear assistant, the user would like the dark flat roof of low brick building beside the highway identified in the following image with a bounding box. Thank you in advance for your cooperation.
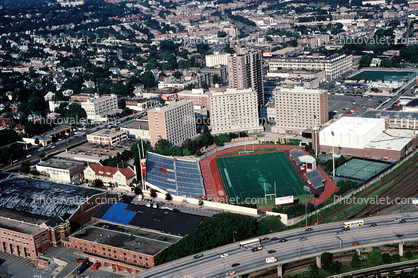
[70,221,181,256]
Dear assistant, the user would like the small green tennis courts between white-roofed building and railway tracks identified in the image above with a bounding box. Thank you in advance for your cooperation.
[335,158,390,180]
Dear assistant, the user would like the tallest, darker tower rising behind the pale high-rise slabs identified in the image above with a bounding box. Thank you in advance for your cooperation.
[228,51,264,106]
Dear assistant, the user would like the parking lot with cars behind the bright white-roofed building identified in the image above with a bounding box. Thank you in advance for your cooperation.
[328,94,385,118]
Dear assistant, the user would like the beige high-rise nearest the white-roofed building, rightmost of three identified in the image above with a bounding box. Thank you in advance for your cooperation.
[272,86,328,133]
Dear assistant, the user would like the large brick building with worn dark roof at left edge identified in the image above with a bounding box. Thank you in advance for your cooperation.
[0,178,120,261]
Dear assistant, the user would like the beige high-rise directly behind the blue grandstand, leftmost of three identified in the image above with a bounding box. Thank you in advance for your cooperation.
[148,99,196,146]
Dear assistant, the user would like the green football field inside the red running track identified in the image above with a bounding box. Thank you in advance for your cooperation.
[216,152,305,201]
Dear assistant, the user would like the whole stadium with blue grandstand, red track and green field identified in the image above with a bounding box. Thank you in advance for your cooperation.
[145,144,338,204]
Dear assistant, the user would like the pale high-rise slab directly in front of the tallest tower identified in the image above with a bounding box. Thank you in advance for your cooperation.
[209,88,263,133]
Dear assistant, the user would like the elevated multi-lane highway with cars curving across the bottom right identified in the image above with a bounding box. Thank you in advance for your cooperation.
[135,214,418,278]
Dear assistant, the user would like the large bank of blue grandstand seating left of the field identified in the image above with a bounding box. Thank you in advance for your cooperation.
[145,152,205,198]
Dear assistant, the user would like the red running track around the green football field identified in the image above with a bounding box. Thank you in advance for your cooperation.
[200,145,338,204]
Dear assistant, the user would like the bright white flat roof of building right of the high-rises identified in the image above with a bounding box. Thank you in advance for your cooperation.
[320,117,385,135]
